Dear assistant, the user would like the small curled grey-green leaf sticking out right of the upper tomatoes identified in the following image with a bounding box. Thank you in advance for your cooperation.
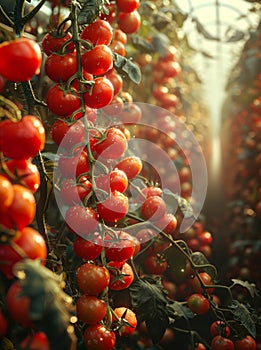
[113,52,141,84]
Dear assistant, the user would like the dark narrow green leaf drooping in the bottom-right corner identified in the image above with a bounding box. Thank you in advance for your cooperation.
[228,300,256,338]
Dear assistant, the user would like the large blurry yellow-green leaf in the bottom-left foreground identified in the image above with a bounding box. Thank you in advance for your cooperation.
[14,259,72,349]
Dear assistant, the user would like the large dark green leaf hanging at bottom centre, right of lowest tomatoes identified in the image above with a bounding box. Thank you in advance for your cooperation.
[130,276,169,344]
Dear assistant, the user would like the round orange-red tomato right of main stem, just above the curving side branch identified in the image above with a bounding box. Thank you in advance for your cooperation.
[141,196,166,221]
